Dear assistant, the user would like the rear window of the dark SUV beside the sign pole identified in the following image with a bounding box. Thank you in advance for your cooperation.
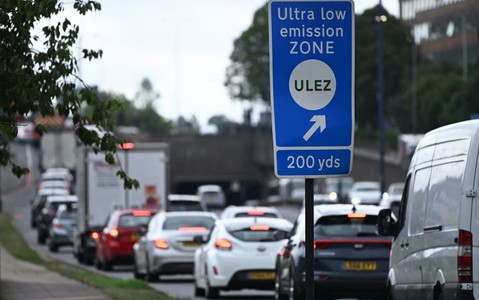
[314,215,378,237]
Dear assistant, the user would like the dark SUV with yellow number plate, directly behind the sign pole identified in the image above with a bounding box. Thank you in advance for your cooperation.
[275,204,392,300]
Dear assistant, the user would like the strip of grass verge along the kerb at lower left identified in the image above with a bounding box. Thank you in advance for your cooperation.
[0,213,188,300]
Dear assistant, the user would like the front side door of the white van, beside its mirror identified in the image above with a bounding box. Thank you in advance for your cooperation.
[389,167,431,300]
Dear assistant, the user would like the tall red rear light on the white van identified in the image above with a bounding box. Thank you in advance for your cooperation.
[457,230,472,283]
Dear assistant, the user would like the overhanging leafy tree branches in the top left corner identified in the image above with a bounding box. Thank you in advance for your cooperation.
[0,0,138,187]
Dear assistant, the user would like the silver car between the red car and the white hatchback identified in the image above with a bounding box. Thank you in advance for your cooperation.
[133,211,218,282]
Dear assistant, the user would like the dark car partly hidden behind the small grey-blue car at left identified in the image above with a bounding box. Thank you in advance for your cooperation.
[37,195,78,245]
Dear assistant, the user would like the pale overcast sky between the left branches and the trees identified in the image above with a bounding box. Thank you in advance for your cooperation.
[71,0,399,131]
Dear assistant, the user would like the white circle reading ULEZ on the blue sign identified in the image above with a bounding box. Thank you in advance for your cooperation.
[289,59,336,110]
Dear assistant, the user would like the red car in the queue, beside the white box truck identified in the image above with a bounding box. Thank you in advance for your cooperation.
[95,209,158,271]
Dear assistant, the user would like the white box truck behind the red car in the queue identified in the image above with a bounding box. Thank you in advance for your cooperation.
[72,143,169,264]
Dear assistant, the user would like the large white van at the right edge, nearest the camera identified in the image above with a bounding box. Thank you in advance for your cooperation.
[378,120,479,300]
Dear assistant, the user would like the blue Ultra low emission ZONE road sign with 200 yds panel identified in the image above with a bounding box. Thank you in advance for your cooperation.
[269,0,354,178]
